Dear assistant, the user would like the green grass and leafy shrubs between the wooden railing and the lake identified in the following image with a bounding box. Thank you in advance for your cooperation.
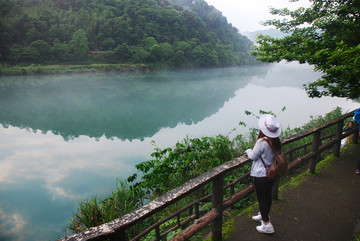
[67,107,343,240]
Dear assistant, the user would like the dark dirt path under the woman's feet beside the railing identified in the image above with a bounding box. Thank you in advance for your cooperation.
[227,144,360,241]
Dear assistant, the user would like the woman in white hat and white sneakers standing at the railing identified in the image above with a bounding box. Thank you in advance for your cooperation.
[245,115,281,234]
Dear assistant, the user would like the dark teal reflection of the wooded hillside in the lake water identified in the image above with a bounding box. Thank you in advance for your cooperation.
[0,67,267,140]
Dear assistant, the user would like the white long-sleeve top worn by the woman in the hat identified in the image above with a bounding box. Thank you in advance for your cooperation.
[245,138,275,177]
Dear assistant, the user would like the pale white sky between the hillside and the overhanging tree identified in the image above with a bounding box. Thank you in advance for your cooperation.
[205,0,310,32]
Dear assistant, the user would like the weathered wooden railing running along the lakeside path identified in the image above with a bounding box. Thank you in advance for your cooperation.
[61,111,359,241]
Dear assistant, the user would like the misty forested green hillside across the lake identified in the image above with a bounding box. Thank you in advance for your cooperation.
[0,0,254,68]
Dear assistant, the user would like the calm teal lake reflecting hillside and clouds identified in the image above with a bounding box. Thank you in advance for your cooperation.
[0,62,359,240]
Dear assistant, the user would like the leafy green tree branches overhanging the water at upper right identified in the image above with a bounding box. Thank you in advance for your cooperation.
[253,0,360,98]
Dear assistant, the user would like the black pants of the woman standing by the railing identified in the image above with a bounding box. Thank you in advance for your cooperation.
[253,177,275,222]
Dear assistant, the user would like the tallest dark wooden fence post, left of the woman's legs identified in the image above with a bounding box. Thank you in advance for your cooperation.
[212,175,224,241]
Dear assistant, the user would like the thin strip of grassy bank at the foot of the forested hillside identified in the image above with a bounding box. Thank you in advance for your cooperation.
[0,64,157,76]
